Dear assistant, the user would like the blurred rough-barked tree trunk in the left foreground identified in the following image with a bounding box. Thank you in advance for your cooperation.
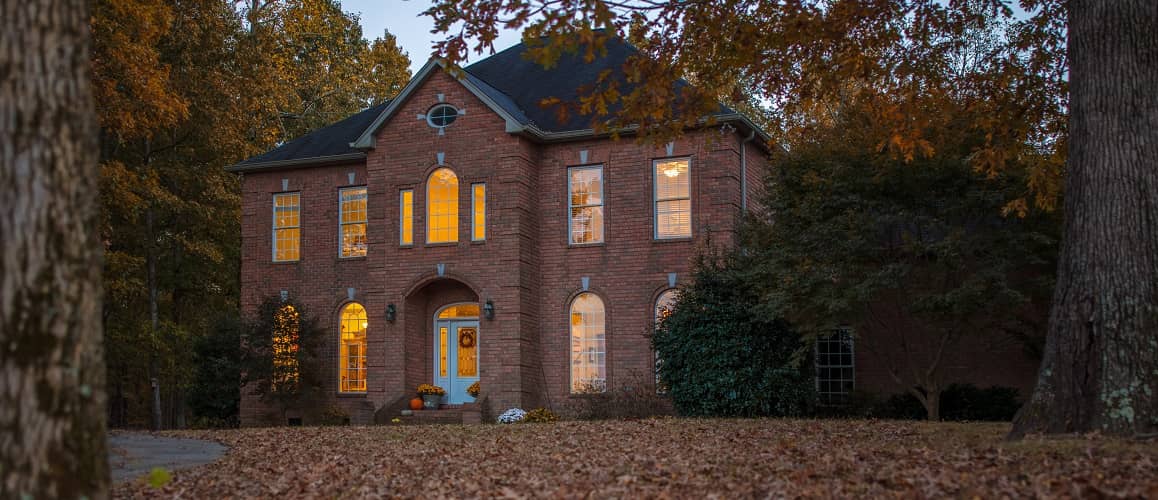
[0,0,109,498]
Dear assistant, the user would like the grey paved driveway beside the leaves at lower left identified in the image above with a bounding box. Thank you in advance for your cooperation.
[109,432,227,483]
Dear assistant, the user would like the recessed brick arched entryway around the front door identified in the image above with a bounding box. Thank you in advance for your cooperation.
[404,277,485,404]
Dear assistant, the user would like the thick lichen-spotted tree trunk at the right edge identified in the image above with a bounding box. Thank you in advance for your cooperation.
[1011,0,1158,438]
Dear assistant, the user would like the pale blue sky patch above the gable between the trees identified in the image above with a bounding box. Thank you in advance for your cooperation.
[342,0,520,74]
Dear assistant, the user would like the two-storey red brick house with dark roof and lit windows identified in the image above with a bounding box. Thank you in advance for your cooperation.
[229,43,1032,425]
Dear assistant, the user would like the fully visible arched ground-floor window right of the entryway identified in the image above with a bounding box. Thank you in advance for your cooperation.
[571,292,607,392]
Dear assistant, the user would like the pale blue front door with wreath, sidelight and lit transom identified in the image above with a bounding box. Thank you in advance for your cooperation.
[434,319,479,404]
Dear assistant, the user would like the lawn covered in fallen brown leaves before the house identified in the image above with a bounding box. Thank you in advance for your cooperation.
[113,419,1158,498]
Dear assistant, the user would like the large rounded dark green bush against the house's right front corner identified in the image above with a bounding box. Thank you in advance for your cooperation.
[652,253,815,417]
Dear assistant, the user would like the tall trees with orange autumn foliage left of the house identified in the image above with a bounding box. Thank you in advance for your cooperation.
[91,0,409,427]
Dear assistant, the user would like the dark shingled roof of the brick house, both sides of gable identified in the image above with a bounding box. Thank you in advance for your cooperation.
[229,38,750,171]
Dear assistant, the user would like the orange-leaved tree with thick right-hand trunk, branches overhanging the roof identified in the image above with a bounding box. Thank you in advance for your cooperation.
[426,0,1158,435]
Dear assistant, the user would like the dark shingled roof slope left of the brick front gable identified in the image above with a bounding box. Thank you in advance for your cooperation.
[237,101,390,167]
